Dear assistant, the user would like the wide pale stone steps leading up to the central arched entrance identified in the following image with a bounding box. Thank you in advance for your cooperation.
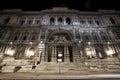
[32,62,87,73]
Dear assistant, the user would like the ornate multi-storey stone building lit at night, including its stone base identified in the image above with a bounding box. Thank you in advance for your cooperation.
[0,7,120,72]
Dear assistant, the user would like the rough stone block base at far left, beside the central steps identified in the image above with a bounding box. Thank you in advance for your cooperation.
[1,58,33,72]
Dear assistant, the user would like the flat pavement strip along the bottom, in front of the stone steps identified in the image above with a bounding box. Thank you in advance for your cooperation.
[0,73,120,80]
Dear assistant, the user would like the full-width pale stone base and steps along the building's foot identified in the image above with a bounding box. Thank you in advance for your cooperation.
[1,58,120,74]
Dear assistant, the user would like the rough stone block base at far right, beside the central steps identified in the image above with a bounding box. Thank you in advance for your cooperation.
[85,58,120,71]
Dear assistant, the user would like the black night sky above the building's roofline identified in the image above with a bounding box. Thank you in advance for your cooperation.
[0,0,120,11]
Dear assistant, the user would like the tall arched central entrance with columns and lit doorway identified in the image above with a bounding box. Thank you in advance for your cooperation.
[45,31,73,62]
